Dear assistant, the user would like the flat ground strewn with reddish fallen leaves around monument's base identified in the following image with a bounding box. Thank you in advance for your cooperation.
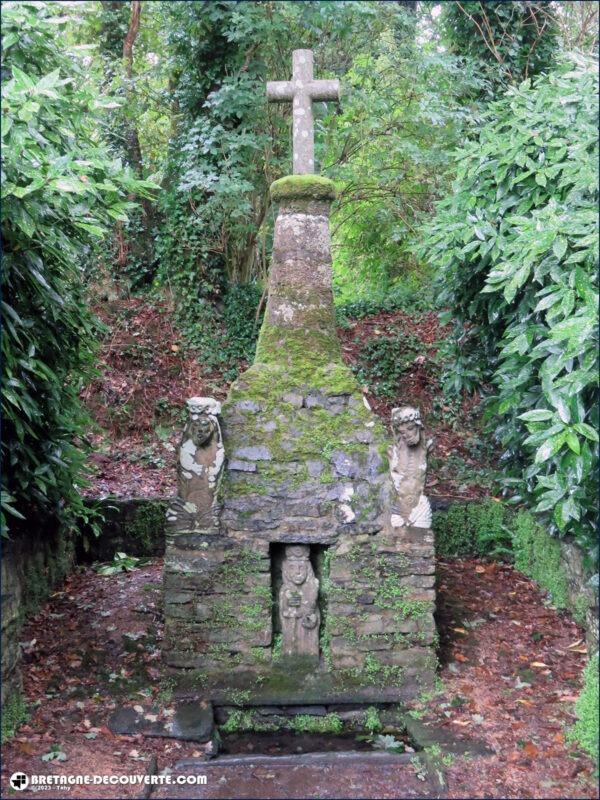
[1,559,597,798]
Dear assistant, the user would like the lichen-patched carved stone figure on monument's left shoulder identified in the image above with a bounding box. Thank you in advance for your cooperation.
[167,397,225,533]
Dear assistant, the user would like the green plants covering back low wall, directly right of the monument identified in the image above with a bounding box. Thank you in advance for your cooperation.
[433,498,511,558]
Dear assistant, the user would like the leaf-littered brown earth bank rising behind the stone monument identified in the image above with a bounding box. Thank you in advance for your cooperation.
[82,296,493,499]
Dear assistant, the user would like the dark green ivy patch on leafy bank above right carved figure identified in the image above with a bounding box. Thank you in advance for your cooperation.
[353,333,432,399]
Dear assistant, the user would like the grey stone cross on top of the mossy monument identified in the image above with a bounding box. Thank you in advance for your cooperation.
[267,50,340,175]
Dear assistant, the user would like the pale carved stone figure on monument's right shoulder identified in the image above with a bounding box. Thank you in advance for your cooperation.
[388,406,433,528]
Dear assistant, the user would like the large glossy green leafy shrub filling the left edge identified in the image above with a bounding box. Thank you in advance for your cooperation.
[2,3,155,536]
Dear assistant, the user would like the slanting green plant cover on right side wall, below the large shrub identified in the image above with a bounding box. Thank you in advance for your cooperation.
[511,511,569,608]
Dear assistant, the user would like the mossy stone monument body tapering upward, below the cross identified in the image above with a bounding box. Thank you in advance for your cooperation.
[164,175,435,705]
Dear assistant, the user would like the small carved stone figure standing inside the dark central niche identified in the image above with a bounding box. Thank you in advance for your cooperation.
[279,545,321,658]
